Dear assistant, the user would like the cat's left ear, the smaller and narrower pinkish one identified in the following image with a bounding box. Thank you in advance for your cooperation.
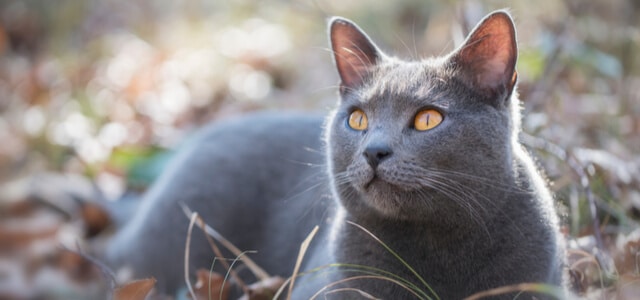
[329,17,382,93]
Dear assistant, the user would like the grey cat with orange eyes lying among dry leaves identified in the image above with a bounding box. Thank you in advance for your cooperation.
[106,11,565,299]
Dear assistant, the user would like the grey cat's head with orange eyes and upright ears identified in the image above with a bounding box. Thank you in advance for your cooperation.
[326,11,518,220]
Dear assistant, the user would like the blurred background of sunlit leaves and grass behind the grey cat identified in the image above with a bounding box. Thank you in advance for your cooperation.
[0,0,640,299]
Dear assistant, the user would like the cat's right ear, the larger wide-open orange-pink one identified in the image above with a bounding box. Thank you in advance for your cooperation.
[451,11,518,101]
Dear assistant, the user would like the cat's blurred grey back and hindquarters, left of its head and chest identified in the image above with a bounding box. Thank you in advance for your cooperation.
[107,112,328,290]
